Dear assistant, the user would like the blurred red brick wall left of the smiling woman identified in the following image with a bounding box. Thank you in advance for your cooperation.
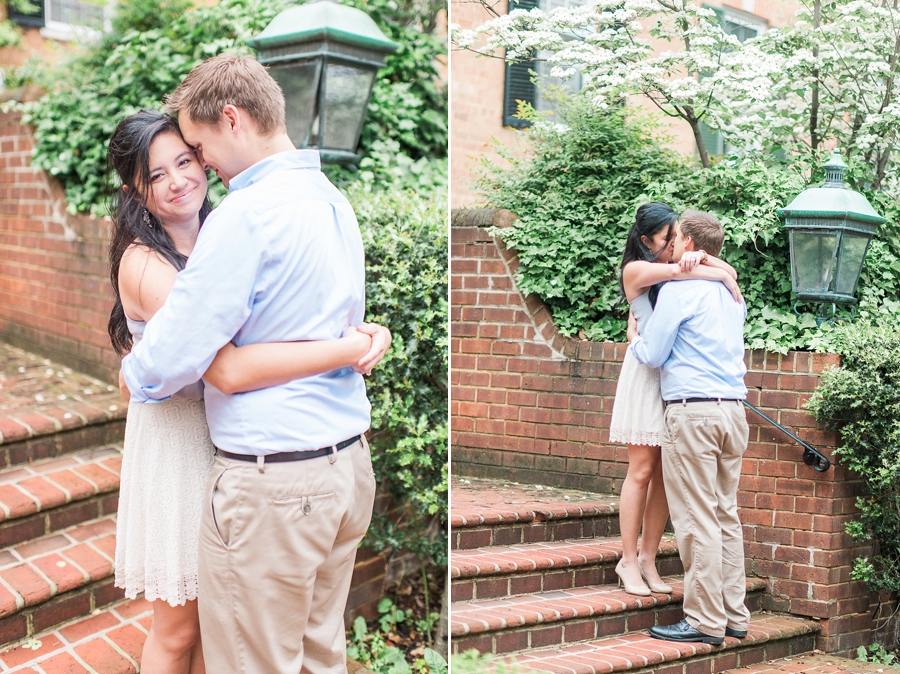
[0,89,118,381]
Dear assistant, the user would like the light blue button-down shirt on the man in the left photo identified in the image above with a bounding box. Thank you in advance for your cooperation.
[122,150,370,455]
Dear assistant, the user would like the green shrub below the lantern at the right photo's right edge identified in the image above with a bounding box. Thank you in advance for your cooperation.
[807,320,900,592]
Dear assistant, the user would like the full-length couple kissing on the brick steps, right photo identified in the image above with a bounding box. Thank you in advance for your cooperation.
[610,202,750,644]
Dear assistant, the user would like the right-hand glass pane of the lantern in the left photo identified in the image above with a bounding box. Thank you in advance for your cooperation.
[321,63,375,152]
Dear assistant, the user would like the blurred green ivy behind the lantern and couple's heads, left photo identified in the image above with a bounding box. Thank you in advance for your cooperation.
[13,0,447,213]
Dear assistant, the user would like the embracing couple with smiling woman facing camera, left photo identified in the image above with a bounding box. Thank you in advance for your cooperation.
[109,55,391,674]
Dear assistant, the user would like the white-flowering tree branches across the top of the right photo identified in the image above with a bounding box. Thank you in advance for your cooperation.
[451,0,900,184]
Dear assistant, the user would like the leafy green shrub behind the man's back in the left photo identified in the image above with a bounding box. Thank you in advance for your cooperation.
[347,183,449,566]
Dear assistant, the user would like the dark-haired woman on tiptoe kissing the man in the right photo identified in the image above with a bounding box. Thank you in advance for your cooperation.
[609,201,741,596]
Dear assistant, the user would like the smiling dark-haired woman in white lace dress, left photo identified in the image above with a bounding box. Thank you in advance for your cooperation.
[109,110,386,674]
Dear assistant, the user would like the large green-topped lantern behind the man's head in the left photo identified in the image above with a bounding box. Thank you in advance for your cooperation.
[247,0,398,164]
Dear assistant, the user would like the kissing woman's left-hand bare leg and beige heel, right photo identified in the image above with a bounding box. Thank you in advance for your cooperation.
[619,445,665,587]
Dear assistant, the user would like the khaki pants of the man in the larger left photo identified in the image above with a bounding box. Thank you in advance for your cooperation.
[199,439,375,674]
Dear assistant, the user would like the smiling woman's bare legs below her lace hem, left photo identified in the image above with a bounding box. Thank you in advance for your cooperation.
[141,599,204,674]
